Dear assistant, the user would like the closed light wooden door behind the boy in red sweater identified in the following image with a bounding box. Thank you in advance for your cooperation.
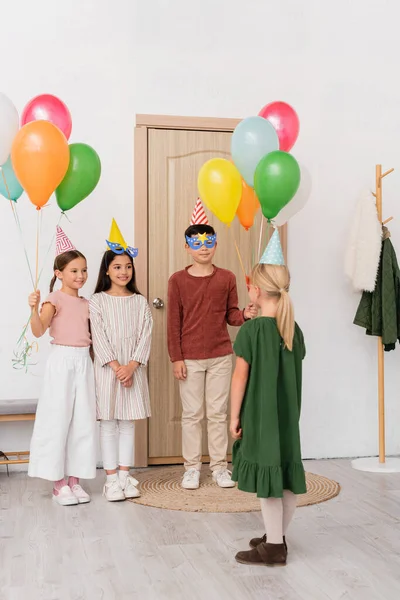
[147,129,259,464]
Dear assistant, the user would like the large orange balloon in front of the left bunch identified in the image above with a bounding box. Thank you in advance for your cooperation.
[11,121,69,210]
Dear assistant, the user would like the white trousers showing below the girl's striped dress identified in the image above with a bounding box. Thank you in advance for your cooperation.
[100,419,135,471]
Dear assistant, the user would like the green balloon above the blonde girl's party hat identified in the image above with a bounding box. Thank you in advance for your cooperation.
[254,150,300,219]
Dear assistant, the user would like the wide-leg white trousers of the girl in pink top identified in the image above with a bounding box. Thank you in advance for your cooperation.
[28,346,96,481]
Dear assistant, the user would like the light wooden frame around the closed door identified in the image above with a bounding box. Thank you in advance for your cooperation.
[134,114,287,467]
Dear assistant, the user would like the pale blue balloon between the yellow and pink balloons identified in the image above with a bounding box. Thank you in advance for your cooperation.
[231,117,279,187]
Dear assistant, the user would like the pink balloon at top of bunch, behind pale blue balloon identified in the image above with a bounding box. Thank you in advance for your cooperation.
[258,102,300,152]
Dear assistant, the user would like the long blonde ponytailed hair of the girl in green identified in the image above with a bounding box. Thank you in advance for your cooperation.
[250,264,294,350]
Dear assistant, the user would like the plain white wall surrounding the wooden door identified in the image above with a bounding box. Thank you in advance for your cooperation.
[0,0,400,464]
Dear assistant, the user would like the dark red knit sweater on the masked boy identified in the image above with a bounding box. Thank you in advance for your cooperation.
[168,267,245,362]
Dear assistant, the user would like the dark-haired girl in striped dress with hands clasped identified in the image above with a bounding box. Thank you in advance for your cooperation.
[89,247,153,502]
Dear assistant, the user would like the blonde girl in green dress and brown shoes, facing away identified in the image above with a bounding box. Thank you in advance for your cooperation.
[230,264,306,566]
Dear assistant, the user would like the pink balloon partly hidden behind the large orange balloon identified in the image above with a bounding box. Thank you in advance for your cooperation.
[21,94,72,140]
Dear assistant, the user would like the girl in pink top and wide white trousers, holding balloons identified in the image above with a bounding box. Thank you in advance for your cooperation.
[28,245,96,506]
